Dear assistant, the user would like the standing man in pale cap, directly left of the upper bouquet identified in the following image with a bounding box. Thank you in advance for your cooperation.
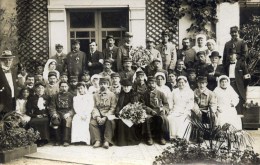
[117,32,133,71]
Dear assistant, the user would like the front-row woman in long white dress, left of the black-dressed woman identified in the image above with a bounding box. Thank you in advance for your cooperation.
[71,82,94,145]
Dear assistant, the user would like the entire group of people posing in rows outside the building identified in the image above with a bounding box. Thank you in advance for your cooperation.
[0,26,250,149]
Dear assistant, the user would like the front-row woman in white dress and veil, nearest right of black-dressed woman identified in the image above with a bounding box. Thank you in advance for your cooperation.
[168,76,194,140]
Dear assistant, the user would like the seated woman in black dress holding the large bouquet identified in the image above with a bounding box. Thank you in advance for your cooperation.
[114,80,141,146]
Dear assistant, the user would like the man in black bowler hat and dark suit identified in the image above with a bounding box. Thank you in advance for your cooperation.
[206,51,225,91]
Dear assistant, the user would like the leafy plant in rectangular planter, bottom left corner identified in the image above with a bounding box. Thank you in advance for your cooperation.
[0,112,40,163]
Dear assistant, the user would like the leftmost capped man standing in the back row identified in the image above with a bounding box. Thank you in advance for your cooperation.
[51,44,67,73]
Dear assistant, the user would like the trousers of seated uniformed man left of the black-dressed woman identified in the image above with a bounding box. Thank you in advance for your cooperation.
[89,119,115,144]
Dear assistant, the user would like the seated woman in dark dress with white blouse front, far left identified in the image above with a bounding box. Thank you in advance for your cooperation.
[26,82,50,147]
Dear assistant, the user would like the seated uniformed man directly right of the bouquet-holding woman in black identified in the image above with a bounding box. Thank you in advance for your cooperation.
[141,76,169,145]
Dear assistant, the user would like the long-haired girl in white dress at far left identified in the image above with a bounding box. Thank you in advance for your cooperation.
[16,87,31,126]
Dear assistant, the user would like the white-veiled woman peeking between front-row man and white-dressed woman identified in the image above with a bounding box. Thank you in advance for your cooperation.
[154,72,172,109]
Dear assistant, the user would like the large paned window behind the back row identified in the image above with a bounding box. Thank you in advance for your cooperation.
[68,8,129,53]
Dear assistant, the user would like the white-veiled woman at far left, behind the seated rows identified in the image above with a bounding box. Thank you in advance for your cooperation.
[43,59,60,83]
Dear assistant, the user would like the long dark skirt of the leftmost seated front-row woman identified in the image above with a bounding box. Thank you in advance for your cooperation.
[28,117,50,140]
